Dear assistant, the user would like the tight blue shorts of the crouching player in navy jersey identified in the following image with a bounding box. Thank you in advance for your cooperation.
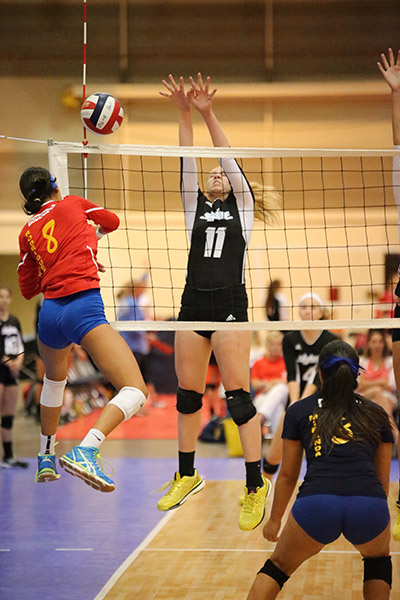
[292,494,390,546]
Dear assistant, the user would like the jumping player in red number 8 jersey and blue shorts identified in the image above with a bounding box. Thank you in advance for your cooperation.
[18,167,146,492]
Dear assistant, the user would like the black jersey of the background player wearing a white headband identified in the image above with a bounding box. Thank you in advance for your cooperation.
[282,331,337,396]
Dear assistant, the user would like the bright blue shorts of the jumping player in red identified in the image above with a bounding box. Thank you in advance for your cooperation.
[38,288,108,349]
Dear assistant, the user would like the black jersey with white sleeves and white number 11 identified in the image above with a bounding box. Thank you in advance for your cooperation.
[181,157,254,291]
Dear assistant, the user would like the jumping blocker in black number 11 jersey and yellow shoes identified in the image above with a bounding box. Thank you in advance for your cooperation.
[158,73,279,530]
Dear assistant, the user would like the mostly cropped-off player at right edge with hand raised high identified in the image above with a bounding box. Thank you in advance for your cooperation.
[378,48,400,542]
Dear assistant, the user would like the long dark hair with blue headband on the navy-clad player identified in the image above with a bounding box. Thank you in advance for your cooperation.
[313,340,390,450]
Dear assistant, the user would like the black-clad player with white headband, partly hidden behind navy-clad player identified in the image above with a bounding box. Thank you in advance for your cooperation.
[263,293,336,479]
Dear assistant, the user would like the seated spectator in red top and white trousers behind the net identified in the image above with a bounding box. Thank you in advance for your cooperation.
[250,332,288,433]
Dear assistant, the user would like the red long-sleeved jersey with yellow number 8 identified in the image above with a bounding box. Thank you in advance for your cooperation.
[17,196,119,300]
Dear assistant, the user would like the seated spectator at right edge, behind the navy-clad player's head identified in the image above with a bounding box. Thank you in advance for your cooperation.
[357,329,398,438]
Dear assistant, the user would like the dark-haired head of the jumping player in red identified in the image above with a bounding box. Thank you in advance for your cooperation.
[19,167,57,215]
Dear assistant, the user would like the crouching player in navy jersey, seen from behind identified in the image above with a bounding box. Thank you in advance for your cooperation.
[248,340,393,600]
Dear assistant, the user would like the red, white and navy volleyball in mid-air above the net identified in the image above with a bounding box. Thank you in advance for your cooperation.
[81,92,124,135]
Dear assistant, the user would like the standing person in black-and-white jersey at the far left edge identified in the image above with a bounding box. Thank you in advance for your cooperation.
[0,285,28,469]
